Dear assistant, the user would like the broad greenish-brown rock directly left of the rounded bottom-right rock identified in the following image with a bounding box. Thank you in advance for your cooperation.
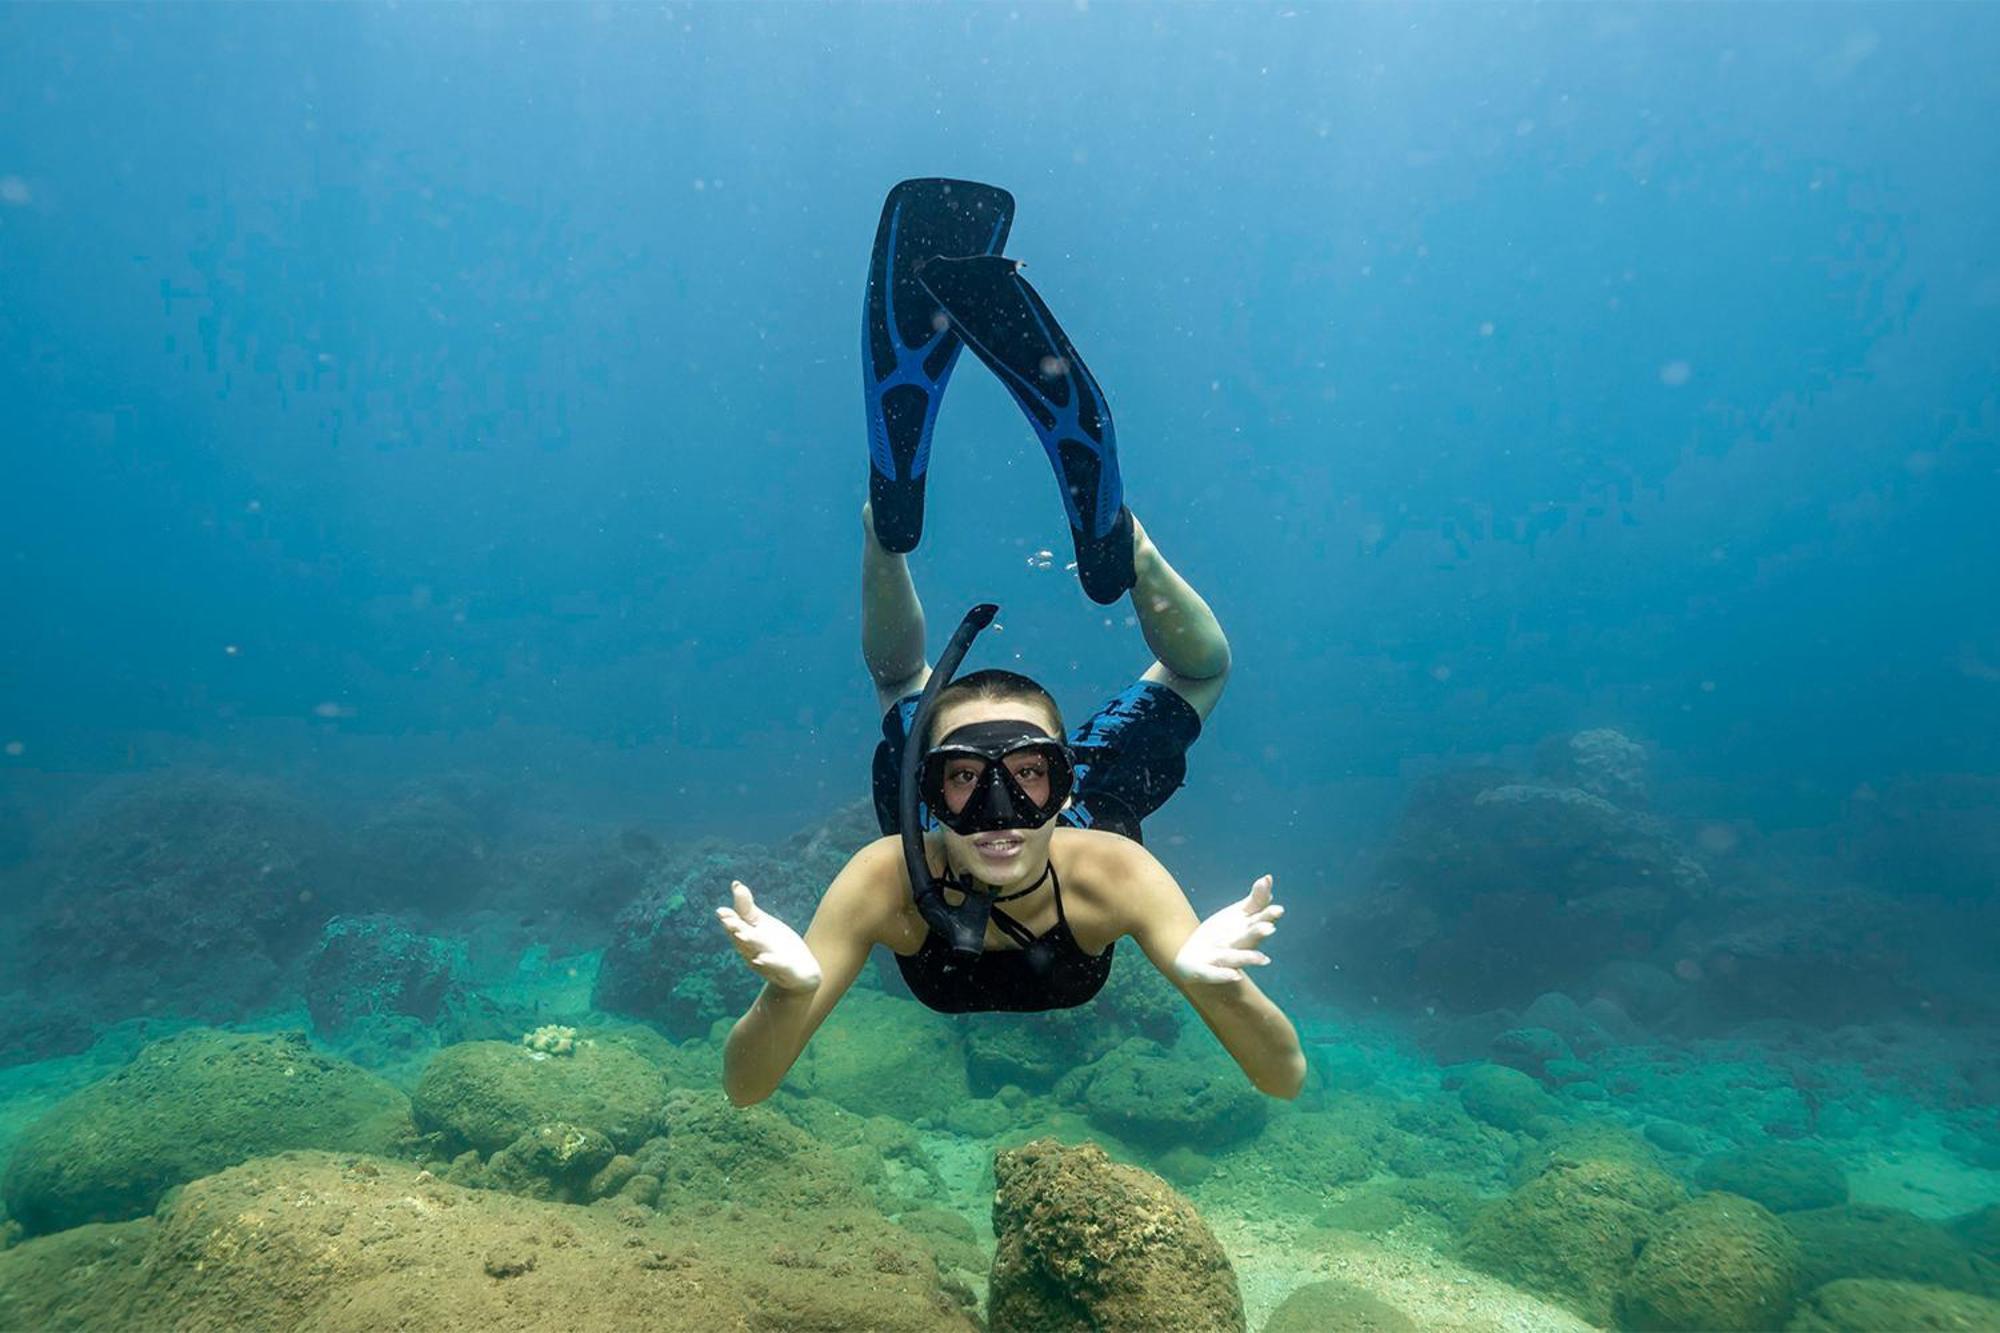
[1464,1159,1688,1325]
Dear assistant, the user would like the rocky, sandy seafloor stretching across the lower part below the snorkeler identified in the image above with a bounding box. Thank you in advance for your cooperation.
[0,752,2000,1333]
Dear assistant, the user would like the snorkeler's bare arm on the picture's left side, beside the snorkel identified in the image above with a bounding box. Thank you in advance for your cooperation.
[722,839,900,1107]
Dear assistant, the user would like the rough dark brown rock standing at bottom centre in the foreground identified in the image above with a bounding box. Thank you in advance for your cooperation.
[988,1139,1244,1333]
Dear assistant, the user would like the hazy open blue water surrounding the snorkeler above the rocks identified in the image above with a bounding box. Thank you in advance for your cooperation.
[0,4,2000,1320]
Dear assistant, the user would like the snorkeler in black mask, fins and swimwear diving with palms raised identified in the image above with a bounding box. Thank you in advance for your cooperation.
[716,180,1306,1105]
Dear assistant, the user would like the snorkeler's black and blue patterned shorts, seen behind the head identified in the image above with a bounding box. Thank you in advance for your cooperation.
[874,681,1202,843]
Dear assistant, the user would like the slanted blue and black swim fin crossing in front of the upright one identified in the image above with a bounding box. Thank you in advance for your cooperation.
[918,254,1134,604]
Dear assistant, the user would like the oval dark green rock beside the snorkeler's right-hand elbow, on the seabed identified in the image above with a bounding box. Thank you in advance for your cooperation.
[1058,1037,1270,1153]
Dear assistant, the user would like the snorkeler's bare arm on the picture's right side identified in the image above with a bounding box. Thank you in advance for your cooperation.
[1106,843,1306,1101]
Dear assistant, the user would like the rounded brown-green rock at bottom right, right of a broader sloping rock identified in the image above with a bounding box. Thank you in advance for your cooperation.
[1618,1193,1798,1333]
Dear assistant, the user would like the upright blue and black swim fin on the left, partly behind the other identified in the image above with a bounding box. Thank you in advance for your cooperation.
[862,176,1014,552]
